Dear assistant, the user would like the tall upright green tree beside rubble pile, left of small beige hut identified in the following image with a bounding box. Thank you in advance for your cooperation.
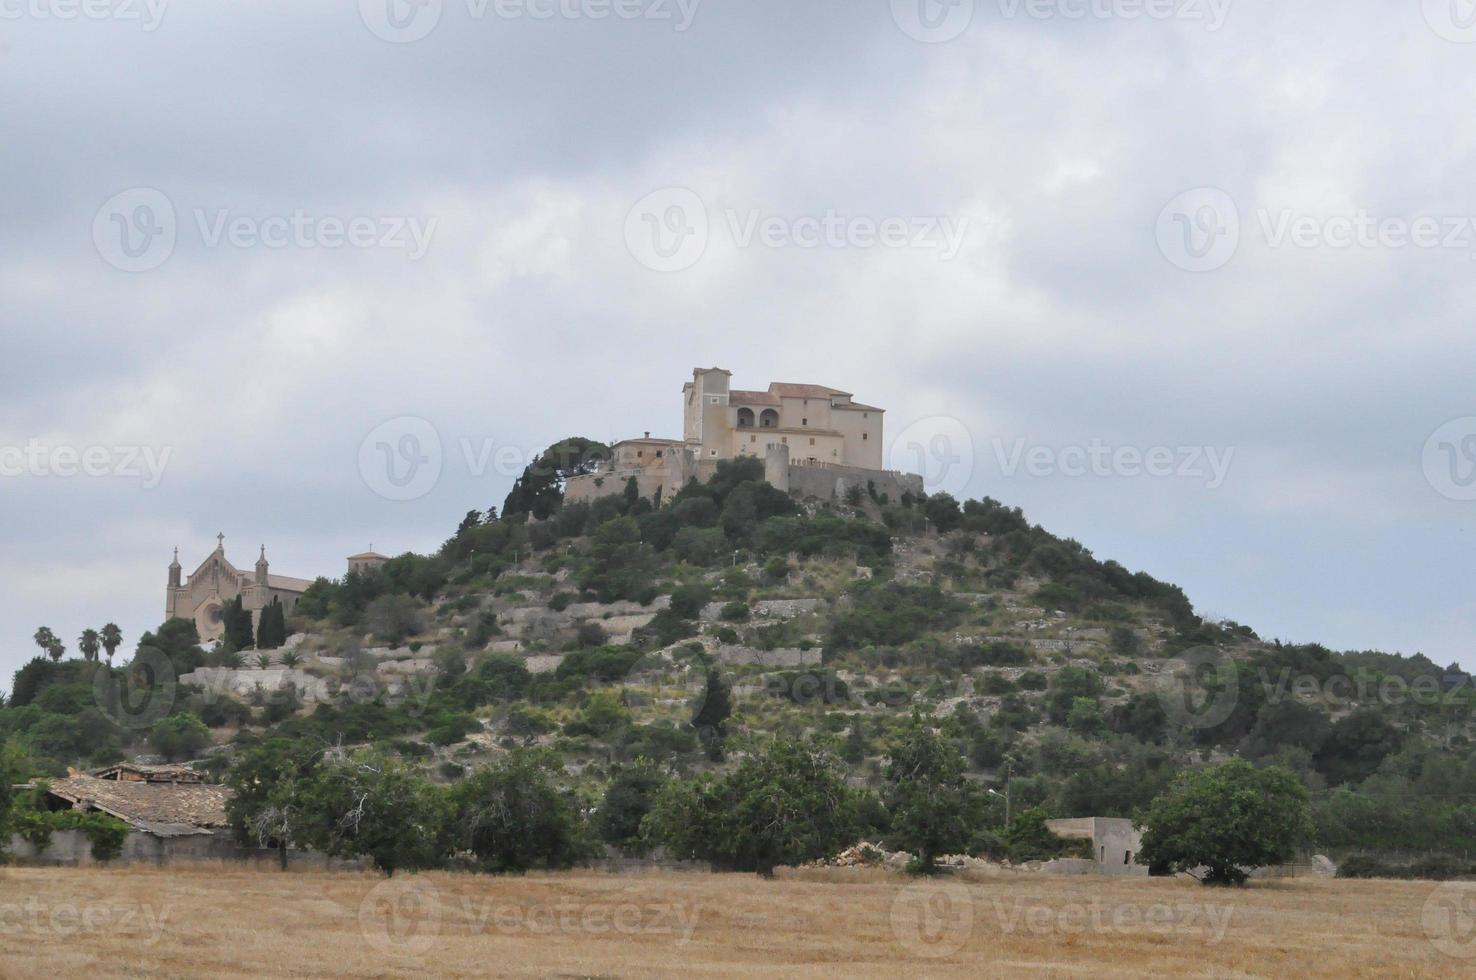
[883,710,977,874]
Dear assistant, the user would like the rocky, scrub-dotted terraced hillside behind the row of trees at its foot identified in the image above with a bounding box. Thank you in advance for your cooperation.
[0,451,1476,855]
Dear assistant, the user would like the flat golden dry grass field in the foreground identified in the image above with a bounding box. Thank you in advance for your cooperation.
[0,866,1476,979]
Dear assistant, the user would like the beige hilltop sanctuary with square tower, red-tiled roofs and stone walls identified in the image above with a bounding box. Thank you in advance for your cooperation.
[564,368,923,500]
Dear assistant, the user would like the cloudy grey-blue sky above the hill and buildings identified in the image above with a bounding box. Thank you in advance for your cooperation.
[0,0,1476,685]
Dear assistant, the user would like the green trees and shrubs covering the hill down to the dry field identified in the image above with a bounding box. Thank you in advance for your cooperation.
[0,448,1476,878]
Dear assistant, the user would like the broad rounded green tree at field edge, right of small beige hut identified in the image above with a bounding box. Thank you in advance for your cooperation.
[1137,759,1312,884]
